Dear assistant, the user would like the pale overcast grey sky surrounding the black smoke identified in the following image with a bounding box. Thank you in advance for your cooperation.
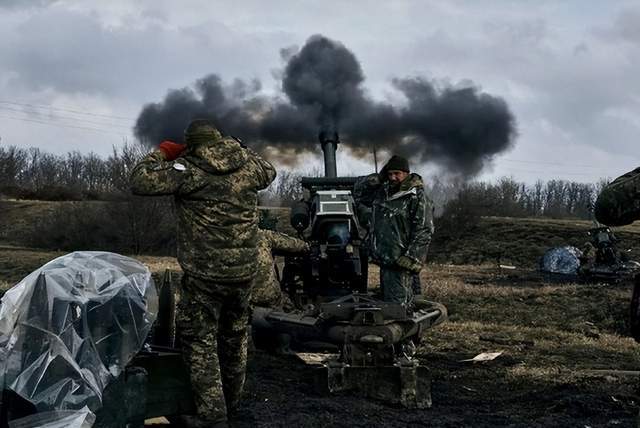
[0,0,640,182]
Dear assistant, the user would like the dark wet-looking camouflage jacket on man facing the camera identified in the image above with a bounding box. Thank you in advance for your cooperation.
[353,174,433,266]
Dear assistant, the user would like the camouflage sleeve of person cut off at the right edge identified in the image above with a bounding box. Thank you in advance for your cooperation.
[593,168,640,226]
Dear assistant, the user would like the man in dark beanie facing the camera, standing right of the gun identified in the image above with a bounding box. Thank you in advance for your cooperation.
[354,156,433,305]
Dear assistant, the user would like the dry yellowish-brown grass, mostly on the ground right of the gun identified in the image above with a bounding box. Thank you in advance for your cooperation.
[0,247,640,426]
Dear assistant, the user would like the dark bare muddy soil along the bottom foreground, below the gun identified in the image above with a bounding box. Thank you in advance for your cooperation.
[236,352,636,427]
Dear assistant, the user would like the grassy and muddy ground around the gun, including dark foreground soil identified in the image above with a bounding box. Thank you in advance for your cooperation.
[0,246,640,427]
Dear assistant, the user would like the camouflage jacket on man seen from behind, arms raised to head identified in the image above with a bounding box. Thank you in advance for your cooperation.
[131,138,276,282]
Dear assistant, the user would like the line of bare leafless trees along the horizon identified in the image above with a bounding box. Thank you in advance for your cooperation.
[0,143,607,219]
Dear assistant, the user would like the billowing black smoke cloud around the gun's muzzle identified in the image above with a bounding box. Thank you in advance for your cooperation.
[135,36,516,176]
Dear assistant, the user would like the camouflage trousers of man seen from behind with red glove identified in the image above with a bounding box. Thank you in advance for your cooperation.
[177,274,250,422]
